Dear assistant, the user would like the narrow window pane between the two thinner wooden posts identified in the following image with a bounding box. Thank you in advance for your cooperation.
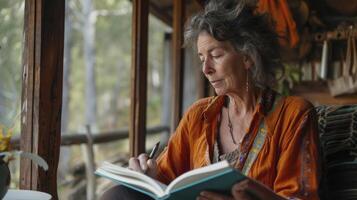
[146,15,171,150]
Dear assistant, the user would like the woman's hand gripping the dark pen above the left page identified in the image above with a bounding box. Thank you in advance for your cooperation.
[128,153,157,179]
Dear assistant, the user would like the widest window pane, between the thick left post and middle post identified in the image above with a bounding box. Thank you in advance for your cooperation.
[58,0,132,199]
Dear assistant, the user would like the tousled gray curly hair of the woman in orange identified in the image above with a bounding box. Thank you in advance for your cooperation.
[184,0,283,87]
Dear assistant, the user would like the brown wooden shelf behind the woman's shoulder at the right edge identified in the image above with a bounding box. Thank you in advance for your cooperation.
[291,81,357,106]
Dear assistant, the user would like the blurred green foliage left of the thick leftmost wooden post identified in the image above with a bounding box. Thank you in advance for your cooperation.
[0,0,24,132]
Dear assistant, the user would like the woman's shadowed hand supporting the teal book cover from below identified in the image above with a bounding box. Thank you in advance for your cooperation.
[197,179,284,200]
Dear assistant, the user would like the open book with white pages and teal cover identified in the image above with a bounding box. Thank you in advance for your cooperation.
[95,161,246,200]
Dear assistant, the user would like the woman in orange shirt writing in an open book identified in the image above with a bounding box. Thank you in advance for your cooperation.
[100,0,319,200]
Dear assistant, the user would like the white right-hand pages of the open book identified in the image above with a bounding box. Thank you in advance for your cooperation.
[165,160,231,194]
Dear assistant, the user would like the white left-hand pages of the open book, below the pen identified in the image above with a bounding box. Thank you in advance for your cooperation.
[99,162,167,193]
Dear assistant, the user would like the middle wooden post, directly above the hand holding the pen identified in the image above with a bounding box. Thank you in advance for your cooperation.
[129,0,149,156]
